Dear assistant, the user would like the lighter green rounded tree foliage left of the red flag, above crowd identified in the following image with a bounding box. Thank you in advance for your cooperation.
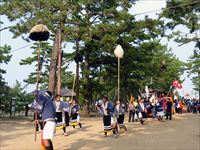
[150,46,183,92]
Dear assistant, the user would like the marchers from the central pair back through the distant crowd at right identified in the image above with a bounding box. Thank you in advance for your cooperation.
[96,94,200,137]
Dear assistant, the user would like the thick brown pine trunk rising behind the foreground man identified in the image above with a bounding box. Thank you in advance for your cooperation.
[48,30,61,93]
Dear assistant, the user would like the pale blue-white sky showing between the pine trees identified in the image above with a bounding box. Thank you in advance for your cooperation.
[0,0,197,98]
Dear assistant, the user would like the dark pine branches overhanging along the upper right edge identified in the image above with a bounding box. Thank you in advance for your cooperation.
[161,0,200,94]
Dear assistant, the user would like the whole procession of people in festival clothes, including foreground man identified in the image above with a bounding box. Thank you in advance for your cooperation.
[31,91,200,150]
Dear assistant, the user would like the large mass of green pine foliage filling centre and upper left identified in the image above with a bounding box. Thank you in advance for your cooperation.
[0,0,185,110]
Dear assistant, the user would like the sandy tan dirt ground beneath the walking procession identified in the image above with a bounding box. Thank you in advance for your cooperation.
[0,113,200,150]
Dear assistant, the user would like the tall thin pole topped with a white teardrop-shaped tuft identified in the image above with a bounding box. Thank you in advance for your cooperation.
[114,45,124,101]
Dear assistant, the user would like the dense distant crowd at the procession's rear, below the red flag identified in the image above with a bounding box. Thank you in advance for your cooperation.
[127,94,200,124]
